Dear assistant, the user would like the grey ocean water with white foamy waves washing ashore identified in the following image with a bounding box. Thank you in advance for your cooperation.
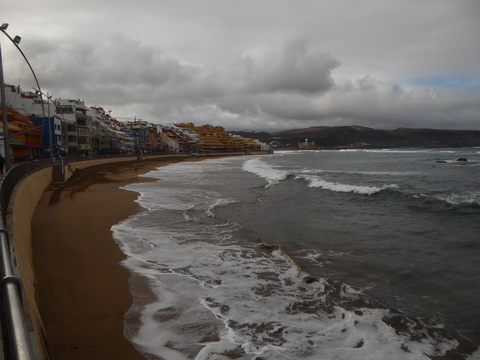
[112,148,480,360]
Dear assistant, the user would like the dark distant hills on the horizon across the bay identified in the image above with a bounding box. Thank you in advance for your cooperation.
[231,126,480,148]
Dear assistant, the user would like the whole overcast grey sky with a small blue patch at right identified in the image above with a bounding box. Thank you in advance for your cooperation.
[0,0,480,131]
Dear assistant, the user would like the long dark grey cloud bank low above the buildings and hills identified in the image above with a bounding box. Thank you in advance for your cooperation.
[12,34,480,128]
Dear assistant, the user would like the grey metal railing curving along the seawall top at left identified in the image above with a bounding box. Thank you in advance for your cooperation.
[0,160,52,360]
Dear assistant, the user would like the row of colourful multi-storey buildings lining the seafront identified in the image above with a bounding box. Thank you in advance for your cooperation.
[0,85,266,161]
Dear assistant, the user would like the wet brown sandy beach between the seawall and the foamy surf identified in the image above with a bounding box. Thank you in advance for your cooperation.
[32,156,207,360]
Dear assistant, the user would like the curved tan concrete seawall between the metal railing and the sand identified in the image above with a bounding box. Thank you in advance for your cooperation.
[7,157,139,359]
